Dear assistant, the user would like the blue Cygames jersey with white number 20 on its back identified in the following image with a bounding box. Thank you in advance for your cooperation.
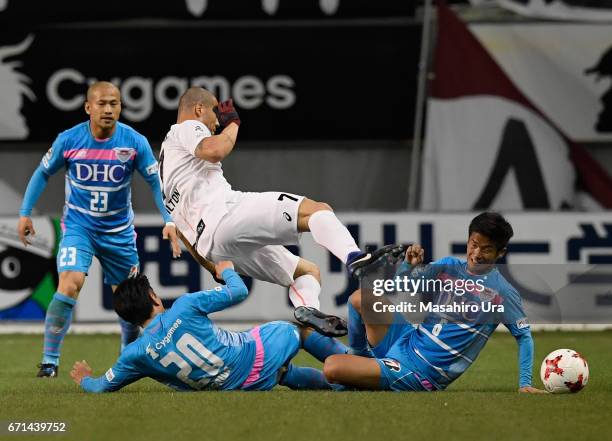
[81,269,263,392]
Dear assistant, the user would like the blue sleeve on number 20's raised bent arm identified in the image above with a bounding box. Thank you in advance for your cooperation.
[186,268,249,314]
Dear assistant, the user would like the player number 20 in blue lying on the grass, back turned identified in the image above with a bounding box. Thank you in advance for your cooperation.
[70,261,347,392]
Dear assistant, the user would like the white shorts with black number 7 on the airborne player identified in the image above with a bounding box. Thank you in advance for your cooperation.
[206,191,304,286]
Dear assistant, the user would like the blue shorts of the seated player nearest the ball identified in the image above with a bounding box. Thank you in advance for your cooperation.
[372,313,436,391]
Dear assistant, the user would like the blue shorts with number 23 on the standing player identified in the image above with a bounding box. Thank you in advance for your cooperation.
[57,225,139,285]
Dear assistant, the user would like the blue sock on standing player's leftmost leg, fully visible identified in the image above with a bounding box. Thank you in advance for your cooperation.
[42,292,76,366]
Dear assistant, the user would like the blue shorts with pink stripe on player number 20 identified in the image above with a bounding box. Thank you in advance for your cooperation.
[241,321,300,390]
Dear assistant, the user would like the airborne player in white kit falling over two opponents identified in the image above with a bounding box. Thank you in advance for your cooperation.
[160,87,373,336]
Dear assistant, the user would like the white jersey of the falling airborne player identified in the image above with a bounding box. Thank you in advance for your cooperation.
[159,120,232,256]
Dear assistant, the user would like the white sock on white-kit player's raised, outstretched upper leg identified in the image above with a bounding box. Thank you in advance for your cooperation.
[308,210,361,263]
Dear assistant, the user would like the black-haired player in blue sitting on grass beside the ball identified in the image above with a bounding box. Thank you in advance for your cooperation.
[323,212,544,393]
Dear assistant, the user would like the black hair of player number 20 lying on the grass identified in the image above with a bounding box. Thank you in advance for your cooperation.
[113,274,153,326]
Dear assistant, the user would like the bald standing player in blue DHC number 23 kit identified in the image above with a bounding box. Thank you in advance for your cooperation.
[17,81,180,377]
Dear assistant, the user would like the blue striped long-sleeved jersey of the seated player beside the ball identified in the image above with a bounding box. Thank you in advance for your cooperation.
[388,256,533,389]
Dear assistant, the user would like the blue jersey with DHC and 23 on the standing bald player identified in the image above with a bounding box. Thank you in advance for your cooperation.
[20,121,171,233]
